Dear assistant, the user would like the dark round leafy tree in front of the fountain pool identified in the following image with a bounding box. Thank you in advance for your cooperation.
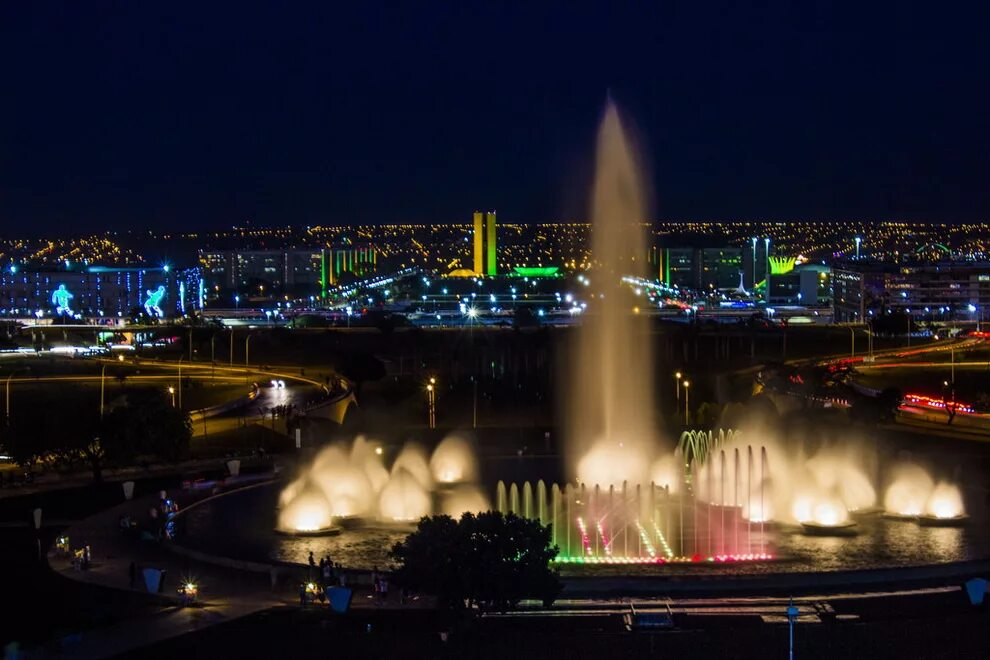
[392,511,562,611]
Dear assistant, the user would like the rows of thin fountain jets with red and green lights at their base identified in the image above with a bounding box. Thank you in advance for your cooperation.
[504,432,771,564]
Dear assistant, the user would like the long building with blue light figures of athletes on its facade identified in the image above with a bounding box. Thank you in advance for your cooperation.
[0,266,202,318]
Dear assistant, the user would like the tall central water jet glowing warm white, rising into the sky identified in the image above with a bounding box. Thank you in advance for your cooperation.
[565,101,656,487]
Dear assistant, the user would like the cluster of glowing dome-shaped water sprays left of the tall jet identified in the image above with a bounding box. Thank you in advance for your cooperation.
[277,436,489,534]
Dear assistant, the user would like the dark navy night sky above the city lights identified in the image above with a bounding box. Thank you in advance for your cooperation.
[0,0,990,234]
